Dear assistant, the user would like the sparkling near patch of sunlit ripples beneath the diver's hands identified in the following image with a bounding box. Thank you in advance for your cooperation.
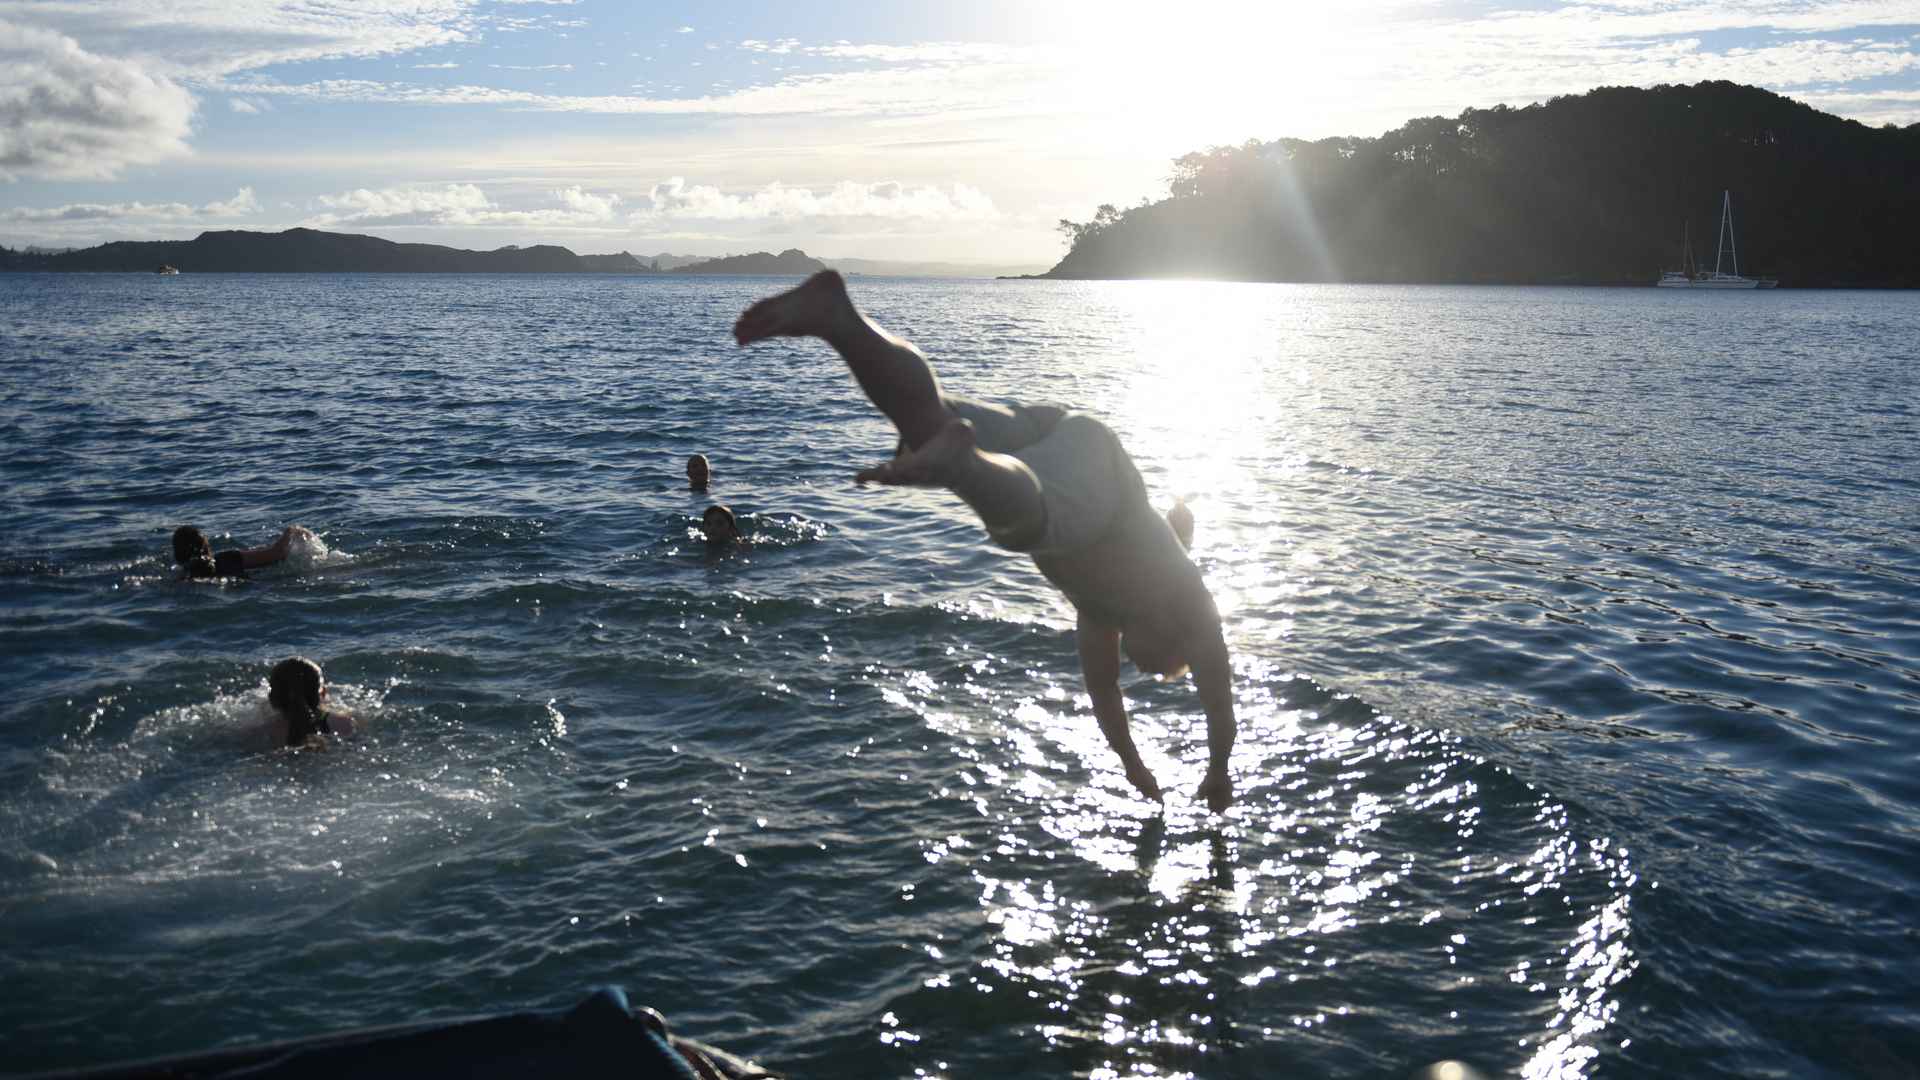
[889,653,1638,1078]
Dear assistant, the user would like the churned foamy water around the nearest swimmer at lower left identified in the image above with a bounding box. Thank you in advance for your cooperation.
[4,678,522,896]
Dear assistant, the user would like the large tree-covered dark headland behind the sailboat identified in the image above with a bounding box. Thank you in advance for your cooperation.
[1037,83,1920,288]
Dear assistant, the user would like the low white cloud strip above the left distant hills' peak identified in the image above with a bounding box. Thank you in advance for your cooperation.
[305,184,620,231]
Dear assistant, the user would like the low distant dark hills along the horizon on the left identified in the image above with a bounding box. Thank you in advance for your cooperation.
[0,229,826,275]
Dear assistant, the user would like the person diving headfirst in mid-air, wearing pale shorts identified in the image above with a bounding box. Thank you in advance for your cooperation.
[733,271,1236,813]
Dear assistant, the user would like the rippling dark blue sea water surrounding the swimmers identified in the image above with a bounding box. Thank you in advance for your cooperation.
[0,275,1920,1078]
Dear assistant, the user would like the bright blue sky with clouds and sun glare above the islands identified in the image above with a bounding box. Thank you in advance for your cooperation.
[0,0,1920,269]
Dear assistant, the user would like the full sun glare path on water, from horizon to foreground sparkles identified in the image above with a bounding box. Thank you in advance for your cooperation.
[864,282,1638,1078]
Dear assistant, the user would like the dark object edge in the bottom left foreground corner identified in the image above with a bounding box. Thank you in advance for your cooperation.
[20,988,780,1080]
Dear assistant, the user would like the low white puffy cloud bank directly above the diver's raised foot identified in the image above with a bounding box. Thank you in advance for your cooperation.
[632,177,998,223]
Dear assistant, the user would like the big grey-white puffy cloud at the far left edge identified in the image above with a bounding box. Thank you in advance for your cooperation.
[0,21,194,181]
